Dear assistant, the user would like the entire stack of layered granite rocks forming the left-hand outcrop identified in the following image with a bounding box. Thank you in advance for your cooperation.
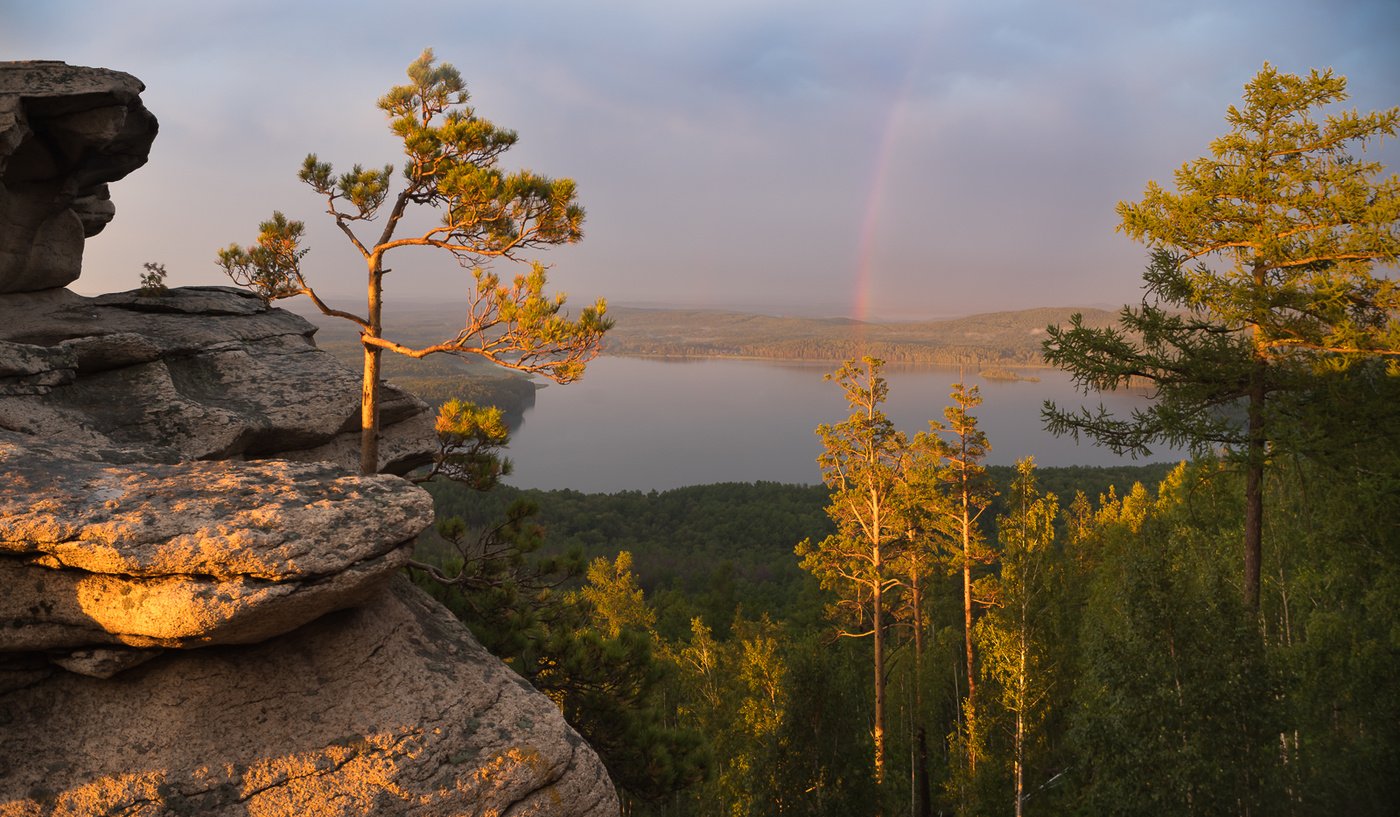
[0,63,617,817]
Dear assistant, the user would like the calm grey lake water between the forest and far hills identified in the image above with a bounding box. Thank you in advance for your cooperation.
[507,357,1182,492]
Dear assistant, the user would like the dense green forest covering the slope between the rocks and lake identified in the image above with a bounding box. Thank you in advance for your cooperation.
[417,355,1400,814]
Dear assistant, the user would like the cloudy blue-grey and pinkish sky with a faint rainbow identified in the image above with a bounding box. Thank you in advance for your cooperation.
[0,0,1400,319]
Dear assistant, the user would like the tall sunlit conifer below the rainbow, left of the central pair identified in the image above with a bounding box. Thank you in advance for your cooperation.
[797,357,907,782]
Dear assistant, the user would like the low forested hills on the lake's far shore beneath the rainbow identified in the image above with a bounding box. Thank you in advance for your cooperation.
[605,306,1116,367]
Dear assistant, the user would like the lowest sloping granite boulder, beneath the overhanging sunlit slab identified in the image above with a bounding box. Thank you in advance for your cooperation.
[0,578,617,817]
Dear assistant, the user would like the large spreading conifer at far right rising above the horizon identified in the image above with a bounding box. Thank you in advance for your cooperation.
[1044,63,1400,613]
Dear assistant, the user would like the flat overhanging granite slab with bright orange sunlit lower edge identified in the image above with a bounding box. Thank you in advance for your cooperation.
[0,432,433,657]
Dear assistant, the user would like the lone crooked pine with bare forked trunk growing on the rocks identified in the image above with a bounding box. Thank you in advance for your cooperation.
[218,49,610,473]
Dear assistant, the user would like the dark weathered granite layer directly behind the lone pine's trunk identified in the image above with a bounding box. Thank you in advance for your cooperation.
[0,287,434,473]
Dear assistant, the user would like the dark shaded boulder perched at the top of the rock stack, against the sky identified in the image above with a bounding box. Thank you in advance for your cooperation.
[0,62,157,292]
